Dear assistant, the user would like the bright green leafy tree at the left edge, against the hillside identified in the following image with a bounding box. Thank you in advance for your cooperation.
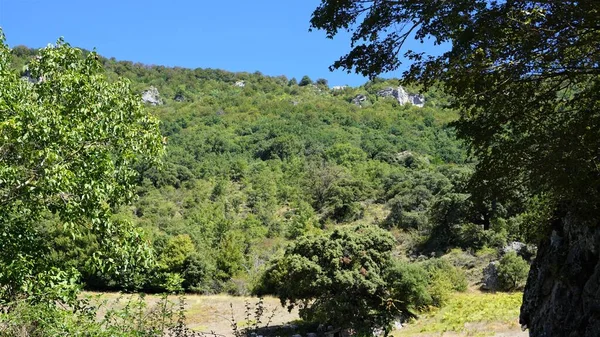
[0,32,163,301]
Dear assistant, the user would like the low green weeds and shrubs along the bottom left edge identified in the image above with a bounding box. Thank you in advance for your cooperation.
[0,295,197,337]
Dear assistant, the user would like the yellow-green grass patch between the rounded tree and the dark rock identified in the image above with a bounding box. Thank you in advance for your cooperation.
[394,291,527,337]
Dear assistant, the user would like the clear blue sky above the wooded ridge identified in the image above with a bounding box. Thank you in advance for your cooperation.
[0,0,440,86]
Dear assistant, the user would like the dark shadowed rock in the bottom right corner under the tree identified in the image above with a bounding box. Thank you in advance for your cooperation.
[519,213,600,337]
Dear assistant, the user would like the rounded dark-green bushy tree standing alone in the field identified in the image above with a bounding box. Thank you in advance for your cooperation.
[256,225,430,335]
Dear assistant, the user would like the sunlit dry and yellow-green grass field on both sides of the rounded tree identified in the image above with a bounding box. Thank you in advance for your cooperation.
[87,291,527,337]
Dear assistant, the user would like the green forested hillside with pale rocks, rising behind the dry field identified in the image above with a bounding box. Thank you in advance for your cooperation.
[8,47,543,293]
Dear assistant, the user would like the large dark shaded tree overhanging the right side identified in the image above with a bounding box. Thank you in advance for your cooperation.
[311,0,600,336]
